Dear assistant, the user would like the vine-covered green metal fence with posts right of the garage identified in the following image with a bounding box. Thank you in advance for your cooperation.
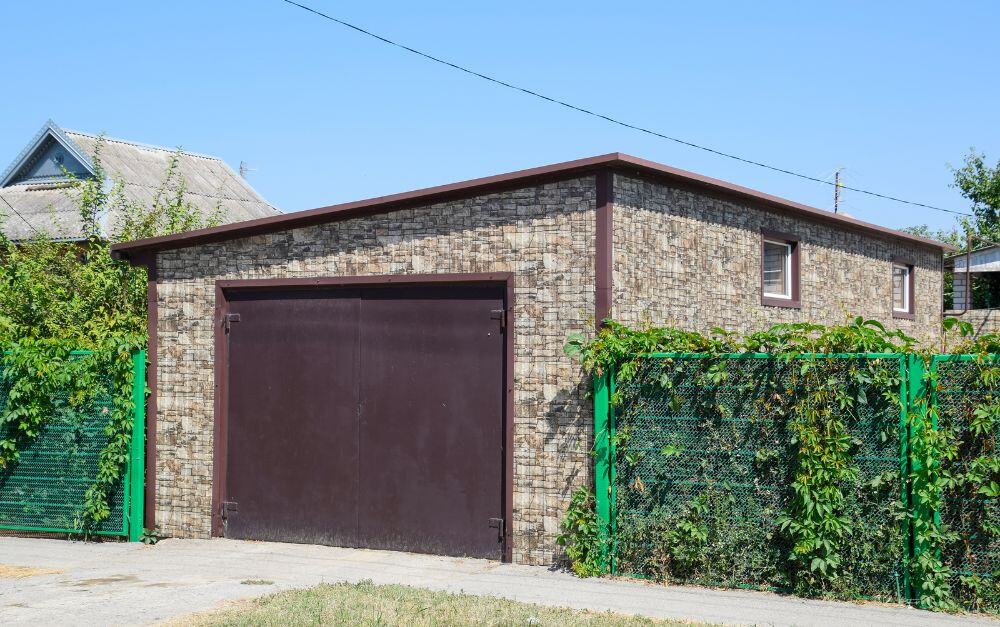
[594,354,1000,601]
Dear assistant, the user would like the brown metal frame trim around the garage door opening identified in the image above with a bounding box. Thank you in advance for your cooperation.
[206,272,516,562]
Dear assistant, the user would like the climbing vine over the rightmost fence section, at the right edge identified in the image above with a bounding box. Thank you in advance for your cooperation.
[910,318,1000,613]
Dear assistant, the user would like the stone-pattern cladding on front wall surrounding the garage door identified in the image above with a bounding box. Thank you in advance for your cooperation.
[156,176,596,564]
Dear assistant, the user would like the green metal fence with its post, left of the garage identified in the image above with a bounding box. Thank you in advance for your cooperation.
[0,351,146,541]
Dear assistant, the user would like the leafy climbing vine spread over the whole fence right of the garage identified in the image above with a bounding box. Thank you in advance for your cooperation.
[565,318,1000,611]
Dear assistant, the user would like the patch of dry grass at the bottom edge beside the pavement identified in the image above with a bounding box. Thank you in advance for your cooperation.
[191,581,689,627]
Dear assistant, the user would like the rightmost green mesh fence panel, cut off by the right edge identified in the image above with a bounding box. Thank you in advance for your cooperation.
[931,356,1000,612]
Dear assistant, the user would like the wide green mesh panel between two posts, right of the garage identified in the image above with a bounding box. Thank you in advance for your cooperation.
[612,356,908,600]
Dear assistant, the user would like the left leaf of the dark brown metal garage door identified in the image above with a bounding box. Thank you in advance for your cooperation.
[222,290,360,546]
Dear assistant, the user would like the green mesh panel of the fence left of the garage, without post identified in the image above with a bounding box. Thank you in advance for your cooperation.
[0,356,127,535]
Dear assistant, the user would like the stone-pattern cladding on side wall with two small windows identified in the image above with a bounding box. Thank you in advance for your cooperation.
[613,174,942,347]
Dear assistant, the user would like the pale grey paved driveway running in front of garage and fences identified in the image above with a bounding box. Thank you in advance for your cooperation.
[0,538,1000,626]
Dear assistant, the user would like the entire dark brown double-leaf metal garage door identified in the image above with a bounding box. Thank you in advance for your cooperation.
[221,285,504,558]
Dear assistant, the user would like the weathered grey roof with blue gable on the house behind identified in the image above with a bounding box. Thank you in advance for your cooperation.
[0,120,281,240]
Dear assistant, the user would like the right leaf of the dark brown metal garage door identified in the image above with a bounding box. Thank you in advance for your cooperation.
[358,287,504,559]
